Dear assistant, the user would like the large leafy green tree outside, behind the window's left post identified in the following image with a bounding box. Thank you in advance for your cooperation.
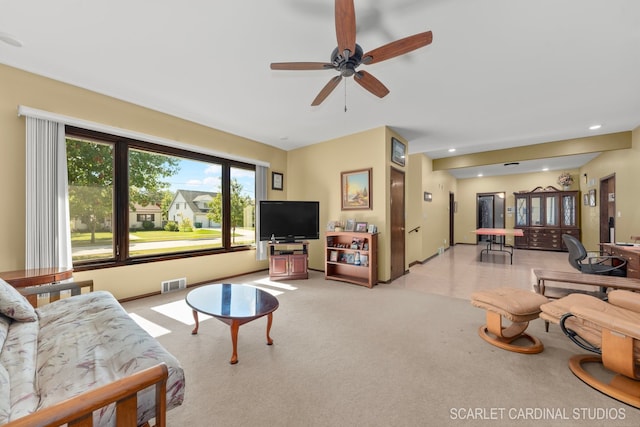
[67,138,180,243]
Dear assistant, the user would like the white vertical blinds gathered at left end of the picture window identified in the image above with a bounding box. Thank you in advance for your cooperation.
[25,116,73,269]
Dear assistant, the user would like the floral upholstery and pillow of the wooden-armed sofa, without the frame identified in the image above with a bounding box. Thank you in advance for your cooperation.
[0,280,185,426]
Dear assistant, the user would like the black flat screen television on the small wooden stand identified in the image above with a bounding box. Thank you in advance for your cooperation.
[259,200,320,242]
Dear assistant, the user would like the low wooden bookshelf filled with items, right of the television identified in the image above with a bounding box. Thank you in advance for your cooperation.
[324,231,378,288]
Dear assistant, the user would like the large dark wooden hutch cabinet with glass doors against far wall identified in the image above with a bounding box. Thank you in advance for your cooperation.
[514,186,580,251]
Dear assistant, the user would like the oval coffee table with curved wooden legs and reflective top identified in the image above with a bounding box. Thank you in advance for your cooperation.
[185,283,279,365]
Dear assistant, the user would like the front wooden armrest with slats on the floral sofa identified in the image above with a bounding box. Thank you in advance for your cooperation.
[5,363,168,427]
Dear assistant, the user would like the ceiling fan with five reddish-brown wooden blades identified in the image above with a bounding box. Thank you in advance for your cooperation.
[271,0,433,106]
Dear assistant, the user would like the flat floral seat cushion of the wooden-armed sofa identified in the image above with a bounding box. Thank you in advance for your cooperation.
[36,291,184,426]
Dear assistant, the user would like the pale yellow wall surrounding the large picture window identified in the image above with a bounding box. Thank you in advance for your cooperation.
[0,65,287,299]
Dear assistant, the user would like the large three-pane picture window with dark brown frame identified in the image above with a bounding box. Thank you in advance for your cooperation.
[67,126,255,269]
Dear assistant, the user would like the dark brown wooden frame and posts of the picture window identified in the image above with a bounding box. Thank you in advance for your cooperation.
[65,125,257,271]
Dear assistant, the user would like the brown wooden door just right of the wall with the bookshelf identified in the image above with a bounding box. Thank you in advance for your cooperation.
[389,168,405,280]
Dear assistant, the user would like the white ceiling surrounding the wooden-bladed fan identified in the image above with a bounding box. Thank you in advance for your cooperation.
[0,0,640,174]
